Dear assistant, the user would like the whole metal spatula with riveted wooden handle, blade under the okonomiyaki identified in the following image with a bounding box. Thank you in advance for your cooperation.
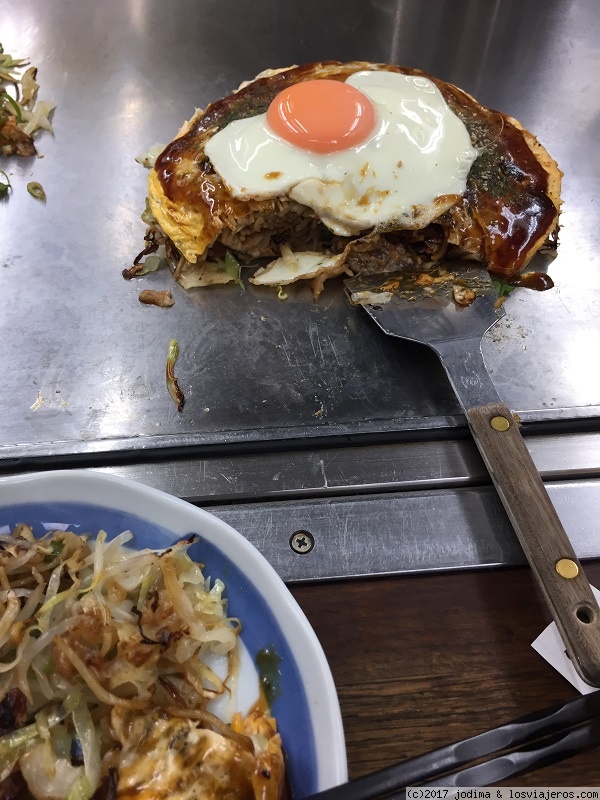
[345,267,600,686]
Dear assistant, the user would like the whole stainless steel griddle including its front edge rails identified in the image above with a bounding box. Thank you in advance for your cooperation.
[0,0,600,579]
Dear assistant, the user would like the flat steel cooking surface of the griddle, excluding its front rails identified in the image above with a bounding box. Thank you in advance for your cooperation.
[0,0,600,459]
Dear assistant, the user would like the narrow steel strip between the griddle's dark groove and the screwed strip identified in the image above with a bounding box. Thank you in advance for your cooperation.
[24,434,600,505]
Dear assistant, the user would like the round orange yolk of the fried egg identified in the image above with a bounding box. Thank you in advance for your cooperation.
[267,80,376,153]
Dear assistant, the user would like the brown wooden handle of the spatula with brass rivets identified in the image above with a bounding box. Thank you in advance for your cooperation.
[467,403,600,686]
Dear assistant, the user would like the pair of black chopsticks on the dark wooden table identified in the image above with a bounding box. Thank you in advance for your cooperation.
[306,692,600,800]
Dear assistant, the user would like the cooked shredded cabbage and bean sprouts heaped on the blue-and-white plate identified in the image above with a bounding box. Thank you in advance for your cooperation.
[0,526,241,800]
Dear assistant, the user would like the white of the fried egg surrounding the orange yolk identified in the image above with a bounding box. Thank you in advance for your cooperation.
[205,71,477,236]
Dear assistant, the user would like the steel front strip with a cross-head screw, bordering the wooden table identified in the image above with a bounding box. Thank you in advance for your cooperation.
[206,481,600,581]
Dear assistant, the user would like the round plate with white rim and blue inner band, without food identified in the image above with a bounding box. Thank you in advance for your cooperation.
[0,471,347,800]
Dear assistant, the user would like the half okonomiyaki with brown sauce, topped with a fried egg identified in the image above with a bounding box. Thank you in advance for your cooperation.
[146,62,561,298]
